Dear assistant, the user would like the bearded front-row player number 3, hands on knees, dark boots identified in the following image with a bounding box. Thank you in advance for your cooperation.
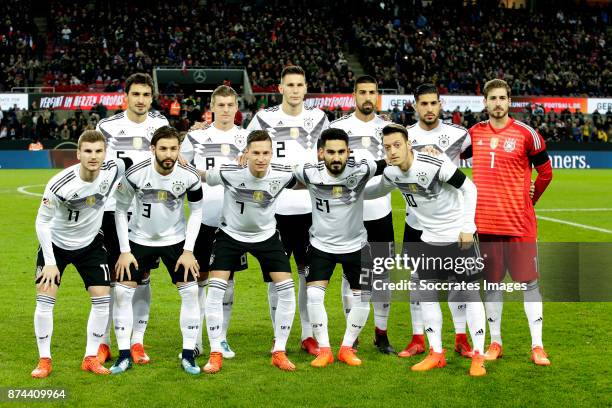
[110,126,202,374]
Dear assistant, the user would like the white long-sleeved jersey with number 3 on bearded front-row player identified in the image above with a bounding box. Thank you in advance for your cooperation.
[115,157,202,252]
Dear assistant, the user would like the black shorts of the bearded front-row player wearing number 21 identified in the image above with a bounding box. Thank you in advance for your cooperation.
[305,245,372,290]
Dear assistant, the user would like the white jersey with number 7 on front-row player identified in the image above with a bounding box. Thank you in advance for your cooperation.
[206,163,296,242]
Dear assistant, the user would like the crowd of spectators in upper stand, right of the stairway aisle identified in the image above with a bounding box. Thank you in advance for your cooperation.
[350,0,612,96]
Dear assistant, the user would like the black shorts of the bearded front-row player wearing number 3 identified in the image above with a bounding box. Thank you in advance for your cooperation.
[124,241,194,284]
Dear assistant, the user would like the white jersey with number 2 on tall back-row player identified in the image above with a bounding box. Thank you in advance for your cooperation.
[247,105,329,215]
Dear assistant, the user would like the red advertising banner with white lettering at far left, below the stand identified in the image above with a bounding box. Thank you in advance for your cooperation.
[30,92,125,111]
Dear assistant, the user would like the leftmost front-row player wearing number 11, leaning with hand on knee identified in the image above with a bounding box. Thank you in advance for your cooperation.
[32,130,129,378]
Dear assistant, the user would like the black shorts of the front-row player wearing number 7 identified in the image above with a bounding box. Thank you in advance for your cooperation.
[208,228,291,282]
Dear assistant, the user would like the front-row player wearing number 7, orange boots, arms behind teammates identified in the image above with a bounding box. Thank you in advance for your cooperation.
[202,130,296,374]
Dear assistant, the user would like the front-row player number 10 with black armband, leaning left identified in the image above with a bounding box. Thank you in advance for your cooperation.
[366,124,486,376]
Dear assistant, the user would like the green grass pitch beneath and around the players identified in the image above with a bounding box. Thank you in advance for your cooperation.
[0,170,612,407]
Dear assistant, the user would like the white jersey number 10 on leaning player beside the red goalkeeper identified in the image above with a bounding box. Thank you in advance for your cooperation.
[372,151,476,243]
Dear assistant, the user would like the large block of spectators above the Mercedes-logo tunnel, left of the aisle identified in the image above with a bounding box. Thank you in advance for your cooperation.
[45,0,352,92]
